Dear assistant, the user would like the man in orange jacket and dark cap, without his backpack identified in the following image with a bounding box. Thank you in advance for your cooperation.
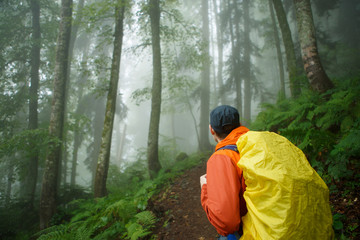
[200,105,249,239]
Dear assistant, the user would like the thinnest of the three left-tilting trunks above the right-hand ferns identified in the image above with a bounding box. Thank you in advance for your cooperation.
[269,0,286,100]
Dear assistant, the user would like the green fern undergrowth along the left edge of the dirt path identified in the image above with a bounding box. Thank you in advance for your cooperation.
[34,154,207,240]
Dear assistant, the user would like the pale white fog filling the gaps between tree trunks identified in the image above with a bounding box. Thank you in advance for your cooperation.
[0,0,360,196]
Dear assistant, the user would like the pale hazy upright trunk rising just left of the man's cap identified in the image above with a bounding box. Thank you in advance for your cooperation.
[199,0,211,151]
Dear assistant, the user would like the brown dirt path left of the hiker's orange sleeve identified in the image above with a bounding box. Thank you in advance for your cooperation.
[151,158,217,240]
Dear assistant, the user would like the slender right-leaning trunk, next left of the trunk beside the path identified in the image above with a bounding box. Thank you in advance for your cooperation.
[94,0,126,198]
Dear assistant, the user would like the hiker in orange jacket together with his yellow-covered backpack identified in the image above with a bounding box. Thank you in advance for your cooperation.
[200,105,333,240]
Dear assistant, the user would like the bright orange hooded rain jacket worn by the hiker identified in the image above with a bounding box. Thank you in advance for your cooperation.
[201,126,249,236]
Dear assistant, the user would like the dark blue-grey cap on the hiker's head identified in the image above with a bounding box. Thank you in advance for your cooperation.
[210,105,240,133]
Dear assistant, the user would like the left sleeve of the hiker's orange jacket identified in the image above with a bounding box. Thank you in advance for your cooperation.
[201,154,241,236]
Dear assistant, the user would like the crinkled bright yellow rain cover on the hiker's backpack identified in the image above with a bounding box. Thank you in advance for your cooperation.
[236,131,334,240]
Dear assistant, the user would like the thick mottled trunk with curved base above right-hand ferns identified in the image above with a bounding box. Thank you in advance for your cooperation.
[294,0,333,93]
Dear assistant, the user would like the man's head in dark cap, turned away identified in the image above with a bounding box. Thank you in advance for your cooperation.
[209,105,240,142]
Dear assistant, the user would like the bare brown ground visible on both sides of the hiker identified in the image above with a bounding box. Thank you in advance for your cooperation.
[149,158,360,240]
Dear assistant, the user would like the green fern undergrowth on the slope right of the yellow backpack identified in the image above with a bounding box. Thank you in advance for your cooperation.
[251,77,360,239]
